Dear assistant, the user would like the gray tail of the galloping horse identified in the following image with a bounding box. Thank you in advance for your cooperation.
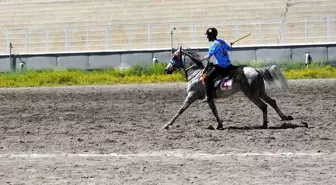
[256,65,289,90]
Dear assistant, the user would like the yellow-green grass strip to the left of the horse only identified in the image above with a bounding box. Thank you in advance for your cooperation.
[0,63,184,87]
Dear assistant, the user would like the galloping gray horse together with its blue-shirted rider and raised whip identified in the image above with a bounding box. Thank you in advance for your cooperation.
[163,28,294,129]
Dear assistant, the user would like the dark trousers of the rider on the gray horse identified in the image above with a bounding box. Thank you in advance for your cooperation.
[204,64,236,99]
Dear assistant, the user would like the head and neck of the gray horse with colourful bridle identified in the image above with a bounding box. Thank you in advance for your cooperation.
[165,47,204,74]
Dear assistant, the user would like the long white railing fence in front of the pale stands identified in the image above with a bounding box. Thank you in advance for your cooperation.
[0,17,336,54]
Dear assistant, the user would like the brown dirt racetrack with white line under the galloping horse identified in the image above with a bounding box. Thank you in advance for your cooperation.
[0,79,336,185]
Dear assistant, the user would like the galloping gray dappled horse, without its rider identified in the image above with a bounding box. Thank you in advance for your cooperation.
[163,47,294,129]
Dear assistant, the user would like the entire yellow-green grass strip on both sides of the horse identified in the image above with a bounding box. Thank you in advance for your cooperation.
[0,61,336,87]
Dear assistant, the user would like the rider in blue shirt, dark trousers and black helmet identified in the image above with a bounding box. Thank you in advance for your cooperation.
[201,28,234,102]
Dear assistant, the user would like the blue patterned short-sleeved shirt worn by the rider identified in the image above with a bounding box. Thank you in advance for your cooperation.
[208,39,232,68]
